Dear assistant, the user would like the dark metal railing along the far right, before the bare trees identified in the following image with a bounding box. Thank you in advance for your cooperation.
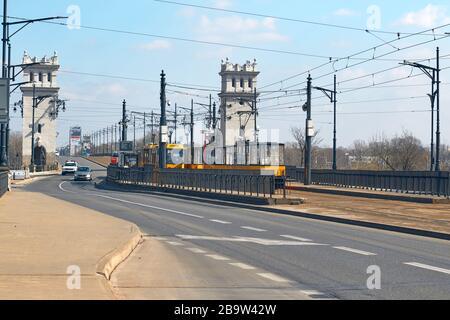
[286,167,450,197]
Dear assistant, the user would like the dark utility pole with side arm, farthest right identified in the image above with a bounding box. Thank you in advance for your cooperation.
[400,47,441,171]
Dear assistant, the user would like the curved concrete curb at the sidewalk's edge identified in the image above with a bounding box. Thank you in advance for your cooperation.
[96,225,142,280]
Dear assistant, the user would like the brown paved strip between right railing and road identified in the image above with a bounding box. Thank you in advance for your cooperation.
[277,191,450,234]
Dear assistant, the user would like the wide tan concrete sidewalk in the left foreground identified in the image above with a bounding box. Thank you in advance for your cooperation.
[0,191,141,299]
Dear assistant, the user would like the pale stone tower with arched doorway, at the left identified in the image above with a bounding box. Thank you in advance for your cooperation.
[20,52,60,166]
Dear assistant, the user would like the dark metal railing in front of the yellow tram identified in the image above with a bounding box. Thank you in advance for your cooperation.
[108,166,286,198]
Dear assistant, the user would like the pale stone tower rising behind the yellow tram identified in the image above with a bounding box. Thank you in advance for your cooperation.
[219,59,259,146]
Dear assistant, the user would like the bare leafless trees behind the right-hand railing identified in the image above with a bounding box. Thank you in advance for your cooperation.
[285,127,450,171]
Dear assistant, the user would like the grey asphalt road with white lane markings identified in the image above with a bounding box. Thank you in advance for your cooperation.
[25,158,450,299]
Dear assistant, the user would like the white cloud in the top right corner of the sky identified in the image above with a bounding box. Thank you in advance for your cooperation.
[399,4,450,28]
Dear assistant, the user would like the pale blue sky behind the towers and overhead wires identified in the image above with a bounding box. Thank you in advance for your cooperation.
[9,0,450,146]
